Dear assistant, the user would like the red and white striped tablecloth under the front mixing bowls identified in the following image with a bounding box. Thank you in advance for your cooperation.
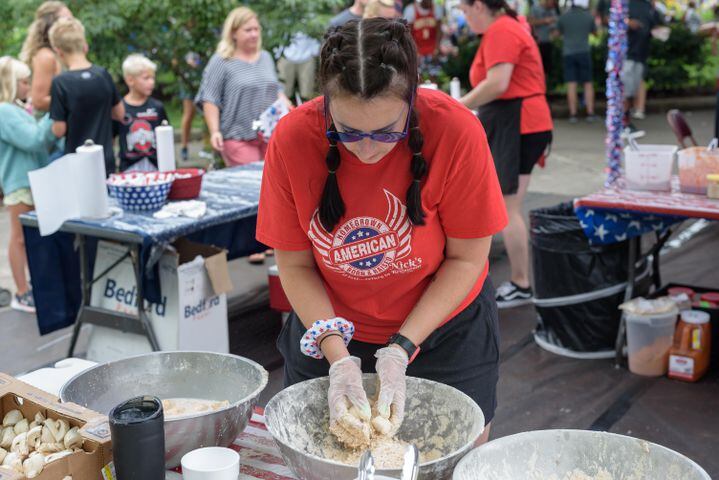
[177,409,297,480]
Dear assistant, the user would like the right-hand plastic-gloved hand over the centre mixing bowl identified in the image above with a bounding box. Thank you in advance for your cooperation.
[372,346,409,435]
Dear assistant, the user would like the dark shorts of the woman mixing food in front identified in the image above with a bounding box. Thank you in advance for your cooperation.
[277,278,499,423]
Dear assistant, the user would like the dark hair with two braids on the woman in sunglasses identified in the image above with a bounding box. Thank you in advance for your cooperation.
[319,18,428,232]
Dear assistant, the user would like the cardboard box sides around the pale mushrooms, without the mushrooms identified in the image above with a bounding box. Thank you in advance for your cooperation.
[0,373,112,480]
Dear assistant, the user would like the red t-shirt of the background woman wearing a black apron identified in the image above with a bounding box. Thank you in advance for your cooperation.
[469,15,553,134]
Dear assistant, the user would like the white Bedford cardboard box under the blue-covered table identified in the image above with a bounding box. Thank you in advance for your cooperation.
[87,239,233,362]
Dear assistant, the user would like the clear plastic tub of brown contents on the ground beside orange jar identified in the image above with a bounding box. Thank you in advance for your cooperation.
[626,308,679,377]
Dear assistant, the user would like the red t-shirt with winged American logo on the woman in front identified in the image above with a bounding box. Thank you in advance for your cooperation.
[257,88,507,344]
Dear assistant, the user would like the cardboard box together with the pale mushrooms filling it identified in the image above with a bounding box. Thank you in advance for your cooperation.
[0,373,112,480]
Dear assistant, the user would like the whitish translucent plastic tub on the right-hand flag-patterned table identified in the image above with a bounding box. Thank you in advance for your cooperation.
[624,145,677,192]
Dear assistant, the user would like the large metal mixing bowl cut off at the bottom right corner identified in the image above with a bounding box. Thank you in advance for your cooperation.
[454,430,710,480]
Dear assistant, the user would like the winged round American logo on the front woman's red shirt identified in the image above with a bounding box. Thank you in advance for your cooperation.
[308,190,412,279]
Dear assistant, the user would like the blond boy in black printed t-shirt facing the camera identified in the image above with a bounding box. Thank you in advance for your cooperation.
[115,54,167,172]
